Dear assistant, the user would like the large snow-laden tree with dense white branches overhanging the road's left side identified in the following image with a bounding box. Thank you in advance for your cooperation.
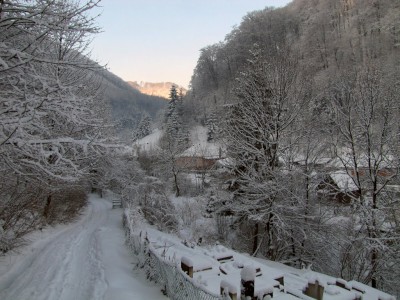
[0,0,106,237]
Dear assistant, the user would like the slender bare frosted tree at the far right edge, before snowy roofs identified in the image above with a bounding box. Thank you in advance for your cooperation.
[327,64,400,291]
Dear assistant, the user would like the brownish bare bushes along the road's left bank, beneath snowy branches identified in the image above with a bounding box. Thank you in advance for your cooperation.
[0,176,88,252]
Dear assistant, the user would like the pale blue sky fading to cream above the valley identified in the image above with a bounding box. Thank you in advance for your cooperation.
[92,0,291,87]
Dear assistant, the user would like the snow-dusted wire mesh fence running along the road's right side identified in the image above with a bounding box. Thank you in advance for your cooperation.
[123,212,225,300]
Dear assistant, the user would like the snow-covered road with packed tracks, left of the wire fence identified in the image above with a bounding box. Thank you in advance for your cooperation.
[0,195,167,300]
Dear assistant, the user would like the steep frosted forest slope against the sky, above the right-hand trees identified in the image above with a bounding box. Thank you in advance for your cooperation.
[191,0,400,115]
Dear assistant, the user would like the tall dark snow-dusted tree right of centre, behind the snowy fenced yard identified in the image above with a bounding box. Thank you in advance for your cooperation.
[220,46,303,259]
